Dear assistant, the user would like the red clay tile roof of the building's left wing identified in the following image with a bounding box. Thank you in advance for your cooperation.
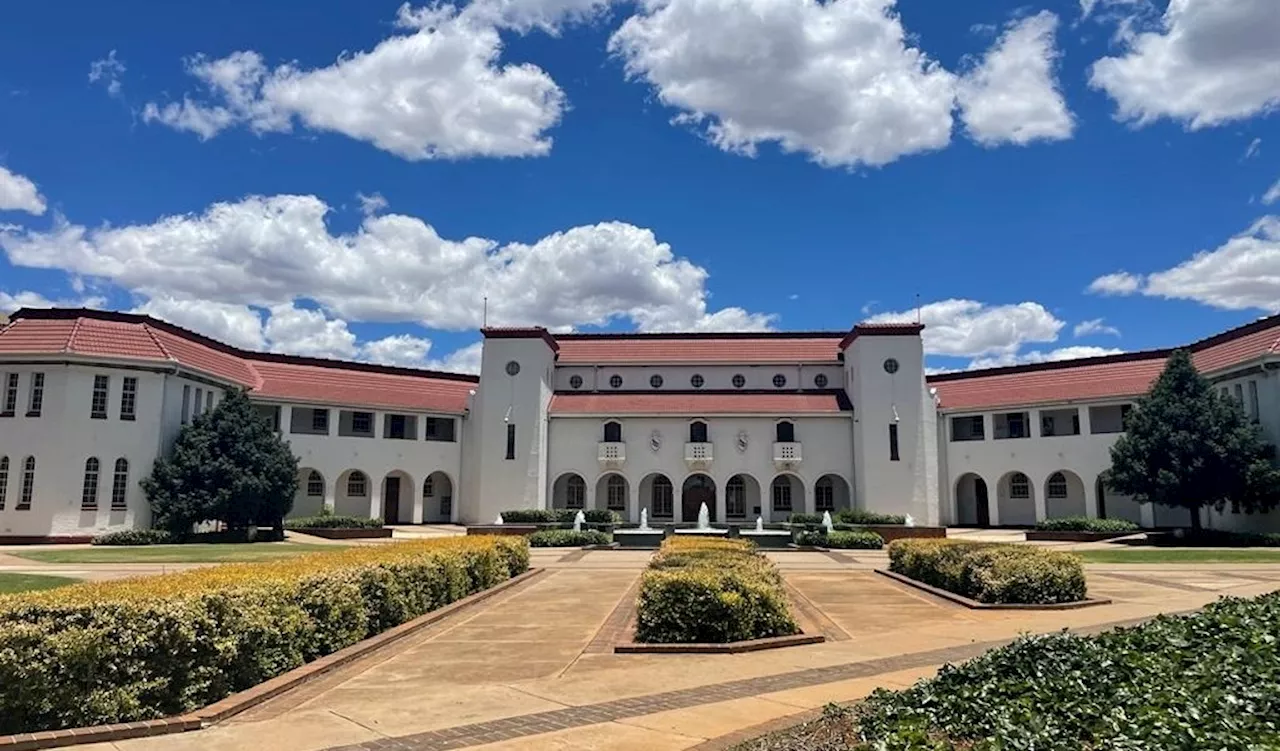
[0,310,479,413]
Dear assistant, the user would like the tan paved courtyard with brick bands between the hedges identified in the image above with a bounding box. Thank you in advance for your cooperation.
[45,550,1280,751]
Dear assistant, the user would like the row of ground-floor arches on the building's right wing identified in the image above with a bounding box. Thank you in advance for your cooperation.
[955,470,1179,527]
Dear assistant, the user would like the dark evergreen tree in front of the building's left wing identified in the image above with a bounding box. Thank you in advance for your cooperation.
[142,390,298,535]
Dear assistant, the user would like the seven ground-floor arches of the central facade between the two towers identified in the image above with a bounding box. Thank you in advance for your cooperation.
[552,472,851,522]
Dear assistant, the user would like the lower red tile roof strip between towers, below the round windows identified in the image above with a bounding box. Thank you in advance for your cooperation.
[550,391,849,415]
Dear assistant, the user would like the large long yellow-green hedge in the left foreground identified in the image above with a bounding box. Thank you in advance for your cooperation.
[0,537,529,734]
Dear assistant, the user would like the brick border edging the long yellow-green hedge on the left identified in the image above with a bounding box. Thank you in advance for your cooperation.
[0,568,547,751]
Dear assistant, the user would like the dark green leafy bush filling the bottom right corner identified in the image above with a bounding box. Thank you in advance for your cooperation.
[849,594,1280,751]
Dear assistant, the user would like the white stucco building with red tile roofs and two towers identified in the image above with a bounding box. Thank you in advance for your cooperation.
[0,310,1280,541]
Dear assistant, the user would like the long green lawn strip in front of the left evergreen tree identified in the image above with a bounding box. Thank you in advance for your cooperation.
[10,542,342,563]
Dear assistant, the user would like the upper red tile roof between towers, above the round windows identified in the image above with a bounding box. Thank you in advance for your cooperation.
[556,331,845,365]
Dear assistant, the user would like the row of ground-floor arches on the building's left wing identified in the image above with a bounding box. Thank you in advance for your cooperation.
[289,467,454,525]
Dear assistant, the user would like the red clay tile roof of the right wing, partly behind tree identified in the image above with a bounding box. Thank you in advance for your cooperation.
[927,316,1280,411]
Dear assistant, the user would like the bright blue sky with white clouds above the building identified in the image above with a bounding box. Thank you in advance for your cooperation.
[0,0,1280,368]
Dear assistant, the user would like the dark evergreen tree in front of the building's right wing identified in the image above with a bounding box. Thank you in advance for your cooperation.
[1107,351,1280,530]
